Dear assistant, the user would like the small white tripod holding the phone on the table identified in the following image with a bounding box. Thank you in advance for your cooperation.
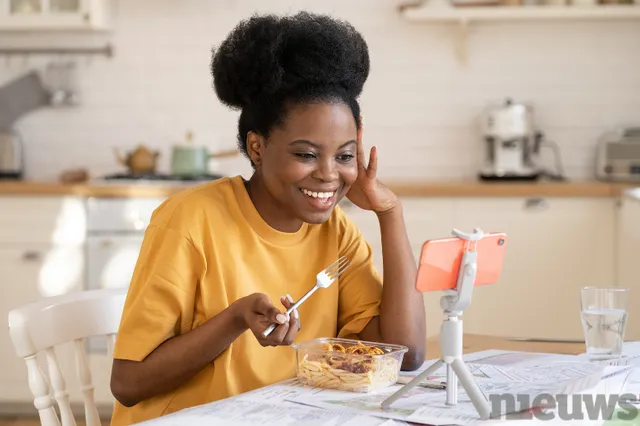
[382,228,490,420]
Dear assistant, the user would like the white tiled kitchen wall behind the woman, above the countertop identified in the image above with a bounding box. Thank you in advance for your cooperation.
[0,0,640,180]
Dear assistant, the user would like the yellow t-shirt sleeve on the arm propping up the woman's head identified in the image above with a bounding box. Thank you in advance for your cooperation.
[338,207,382,339]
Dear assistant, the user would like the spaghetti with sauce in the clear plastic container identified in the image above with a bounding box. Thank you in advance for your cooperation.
[298,342,400,392]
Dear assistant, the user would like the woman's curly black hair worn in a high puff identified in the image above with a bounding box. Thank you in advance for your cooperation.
[211,12,369,165]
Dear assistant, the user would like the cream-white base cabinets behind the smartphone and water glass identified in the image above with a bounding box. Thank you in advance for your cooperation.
[336,197,620,340]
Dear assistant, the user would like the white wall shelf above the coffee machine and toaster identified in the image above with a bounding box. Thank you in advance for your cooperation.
[401,4,640,23]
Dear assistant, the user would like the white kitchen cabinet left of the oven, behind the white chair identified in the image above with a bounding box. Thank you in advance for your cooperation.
[0,196,91,406]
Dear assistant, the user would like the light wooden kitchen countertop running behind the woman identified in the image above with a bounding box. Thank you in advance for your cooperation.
[0,180,640,197]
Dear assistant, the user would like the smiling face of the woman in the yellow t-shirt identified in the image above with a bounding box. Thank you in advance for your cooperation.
[250,103,358,223]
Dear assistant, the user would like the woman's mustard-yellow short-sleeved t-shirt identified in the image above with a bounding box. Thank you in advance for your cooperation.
[111,176,382,426]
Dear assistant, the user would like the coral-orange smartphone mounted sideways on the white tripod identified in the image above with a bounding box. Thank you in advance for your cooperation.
[416,232,507,293]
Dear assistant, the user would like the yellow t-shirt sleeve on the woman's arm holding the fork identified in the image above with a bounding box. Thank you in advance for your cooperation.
[113,225,204,361]
